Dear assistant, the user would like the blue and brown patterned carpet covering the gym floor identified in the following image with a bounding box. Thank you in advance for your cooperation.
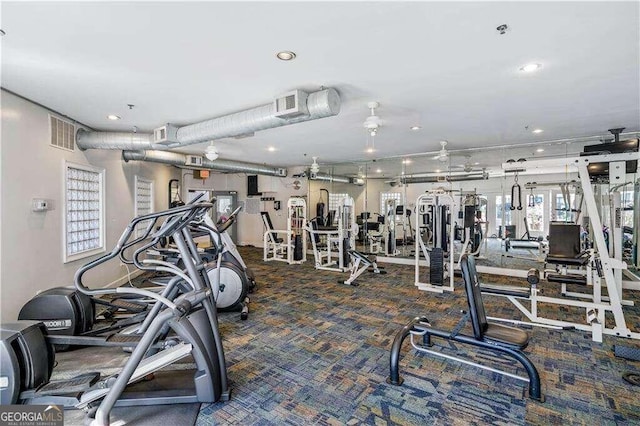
[197,248,640,425]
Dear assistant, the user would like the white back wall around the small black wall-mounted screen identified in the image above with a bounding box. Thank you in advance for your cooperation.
[182,167,315,247]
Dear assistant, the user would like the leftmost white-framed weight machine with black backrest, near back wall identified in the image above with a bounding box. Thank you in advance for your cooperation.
[260,197,307,265]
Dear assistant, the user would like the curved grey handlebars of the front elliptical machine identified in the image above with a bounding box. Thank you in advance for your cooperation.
[73,201,215,306]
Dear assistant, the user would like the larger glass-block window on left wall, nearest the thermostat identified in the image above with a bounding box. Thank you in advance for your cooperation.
[63,162,105,263]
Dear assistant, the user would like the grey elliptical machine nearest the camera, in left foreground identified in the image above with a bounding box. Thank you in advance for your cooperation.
[0,203,230,426]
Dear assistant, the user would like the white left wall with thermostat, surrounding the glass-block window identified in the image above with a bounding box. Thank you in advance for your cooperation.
[0,91,179,321]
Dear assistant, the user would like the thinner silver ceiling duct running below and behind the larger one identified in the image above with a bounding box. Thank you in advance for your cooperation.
[122,151,287,177]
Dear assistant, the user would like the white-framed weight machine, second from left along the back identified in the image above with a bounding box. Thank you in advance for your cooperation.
[305,197,358,272]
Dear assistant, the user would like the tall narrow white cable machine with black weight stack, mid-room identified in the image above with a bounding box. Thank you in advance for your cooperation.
[415,189,455,293]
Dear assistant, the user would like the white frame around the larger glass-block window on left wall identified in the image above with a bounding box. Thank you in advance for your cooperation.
[62,160,106,263]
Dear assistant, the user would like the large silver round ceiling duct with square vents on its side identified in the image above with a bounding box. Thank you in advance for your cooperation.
[76,88,340,150]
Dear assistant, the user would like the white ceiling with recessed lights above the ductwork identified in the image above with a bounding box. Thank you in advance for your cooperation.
[0,1,640,174]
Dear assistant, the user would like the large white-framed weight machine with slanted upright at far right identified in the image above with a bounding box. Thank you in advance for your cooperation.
[483,152,640,342]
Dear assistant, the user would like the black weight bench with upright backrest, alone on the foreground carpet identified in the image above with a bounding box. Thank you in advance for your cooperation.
[387,254,544,402]
